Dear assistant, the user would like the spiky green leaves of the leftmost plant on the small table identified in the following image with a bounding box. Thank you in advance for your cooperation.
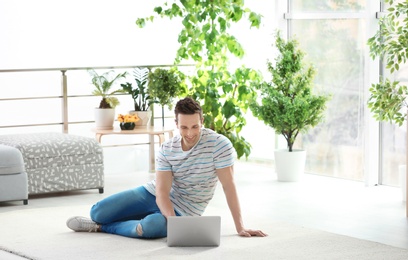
[88,69,127,108]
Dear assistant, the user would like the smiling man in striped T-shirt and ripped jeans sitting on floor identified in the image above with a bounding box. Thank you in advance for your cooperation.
[67,98,266,238]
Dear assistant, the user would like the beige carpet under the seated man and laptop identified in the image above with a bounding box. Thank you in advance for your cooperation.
[0,205,408,260]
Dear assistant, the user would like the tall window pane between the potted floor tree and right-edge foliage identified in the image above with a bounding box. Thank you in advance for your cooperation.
[287,0,368,181]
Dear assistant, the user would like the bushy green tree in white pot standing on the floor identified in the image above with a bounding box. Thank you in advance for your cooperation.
[250,31,329,181]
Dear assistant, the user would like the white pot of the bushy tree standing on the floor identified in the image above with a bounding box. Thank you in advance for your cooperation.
[275,149,306,182]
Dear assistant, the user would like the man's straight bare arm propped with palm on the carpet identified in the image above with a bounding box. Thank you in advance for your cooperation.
[217,166,266,237]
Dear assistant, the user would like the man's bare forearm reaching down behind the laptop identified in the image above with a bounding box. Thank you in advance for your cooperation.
[156,171,176,218]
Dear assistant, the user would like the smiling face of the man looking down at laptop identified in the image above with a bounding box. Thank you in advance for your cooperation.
[176,113,203,150]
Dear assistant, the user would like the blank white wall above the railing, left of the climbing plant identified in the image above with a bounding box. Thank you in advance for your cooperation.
[0,0,177,69]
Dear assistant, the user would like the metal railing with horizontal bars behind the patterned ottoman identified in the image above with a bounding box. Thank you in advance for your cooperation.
[0,64,193,133]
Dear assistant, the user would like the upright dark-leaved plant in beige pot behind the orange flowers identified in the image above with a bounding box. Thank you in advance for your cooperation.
[120,67,155,126]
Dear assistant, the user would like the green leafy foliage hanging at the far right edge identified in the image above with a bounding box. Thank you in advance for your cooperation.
[367,0,408,126]
